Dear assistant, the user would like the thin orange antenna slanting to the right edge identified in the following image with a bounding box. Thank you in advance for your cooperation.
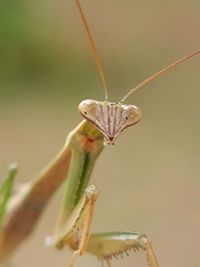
[121,49,200,103]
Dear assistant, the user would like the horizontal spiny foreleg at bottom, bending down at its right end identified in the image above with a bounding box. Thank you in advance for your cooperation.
[86,232,159,267]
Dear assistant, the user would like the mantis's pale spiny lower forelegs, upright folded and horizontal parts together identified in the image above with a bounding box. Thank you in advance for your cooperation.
[51,185,159,267]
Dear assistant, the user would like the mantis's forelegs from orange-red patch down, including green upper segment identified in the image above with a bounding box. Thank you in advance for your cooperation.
[43,121,159,267]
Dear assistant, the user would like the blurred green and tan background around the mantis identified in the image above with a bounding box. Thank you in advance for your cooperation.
[0,0,200,267]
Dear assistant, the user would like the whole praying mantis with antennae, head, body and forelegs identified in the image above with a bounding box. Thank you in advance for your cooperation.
[0,0,200,267]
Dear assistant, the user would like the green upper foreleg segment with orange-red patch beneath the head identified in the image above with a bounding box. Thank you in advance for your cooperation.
[56,120,104,232]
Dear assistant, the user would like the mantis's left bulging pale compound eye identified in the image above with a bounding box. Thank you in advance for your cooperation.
[79,99,98,122]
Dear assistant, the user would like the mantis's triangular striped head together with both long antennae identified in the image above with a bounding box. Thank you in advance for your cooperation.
[76,0,200,144]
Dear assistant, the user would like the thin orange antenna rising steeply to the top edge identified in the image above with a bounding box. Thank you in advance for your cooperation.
[75,0,108,100]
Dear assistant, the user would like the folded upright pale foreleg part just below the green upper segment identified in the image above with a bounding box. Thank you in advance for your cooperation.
[47,185,98,267]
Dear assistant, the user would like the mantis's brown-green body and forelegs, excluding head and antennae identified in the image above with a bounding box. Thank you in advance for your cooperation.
[0,121,159,267]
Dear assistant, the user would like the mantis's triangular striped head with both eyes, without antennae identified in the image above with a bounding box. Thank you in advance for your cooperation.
[79,99,141,144]
